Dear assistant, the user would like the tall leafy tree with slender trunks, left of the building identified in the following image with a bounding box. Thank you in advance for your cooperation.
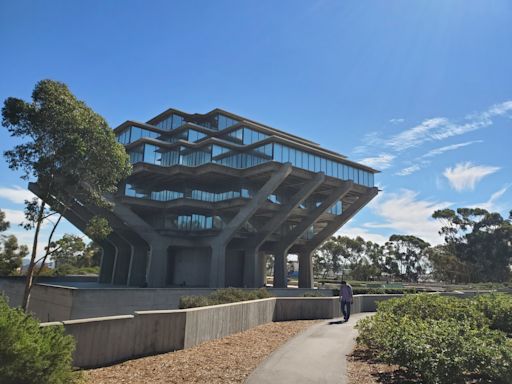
[2,80,131,309]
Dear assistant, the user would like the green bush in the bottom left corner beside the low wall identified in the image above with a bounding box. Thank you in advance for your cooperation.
[0,295,80,384]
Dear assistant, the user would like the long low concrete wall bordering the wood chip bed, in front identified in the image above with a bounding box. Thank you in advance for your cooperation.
[41,295,406,368]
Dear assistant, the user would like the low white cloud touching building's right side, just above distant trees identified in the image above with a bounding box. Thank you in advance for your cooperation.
[363,189,451,244]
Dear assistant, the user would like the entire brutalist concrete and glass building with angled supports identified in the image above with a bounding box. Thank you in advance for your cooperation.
[30,109,378,288]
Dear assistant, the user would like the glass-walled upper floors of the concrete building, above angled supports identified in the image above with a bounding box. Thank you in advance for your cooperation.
[115,109,378,187]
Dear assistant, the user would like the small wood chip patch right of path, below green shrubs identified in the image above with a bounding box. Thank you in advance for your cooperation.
[347,346,420,384]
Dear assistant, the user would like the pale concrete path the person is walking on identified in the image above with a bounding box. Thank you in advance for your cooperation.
[245,313,371,384]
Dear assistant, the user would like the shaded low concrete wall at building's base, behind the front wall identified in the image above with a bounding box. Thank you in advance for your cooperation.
[0,277,332,322]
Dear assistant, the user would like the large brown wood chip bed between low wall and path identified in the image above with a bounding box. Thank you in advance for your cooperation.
[83,320,318,384]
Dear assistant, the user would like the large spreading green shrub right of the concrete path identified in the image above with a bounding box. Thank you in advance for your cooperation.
[357,294,512,384]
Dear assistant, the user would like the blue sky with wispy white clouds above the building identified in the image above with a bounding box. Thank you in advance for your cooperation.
[0,0,512,252]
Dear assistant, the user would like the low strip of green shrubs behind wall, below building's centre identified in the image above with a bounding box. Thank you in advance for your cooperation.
[180,288,272,309]
